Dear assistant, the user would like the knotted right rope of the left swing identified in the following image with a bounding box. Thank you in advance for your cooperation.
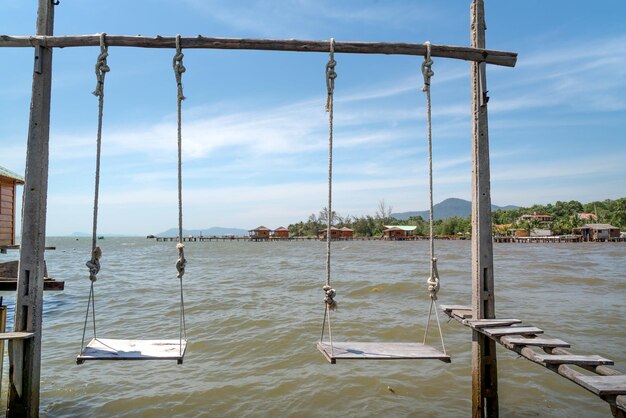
[172,35,187,355]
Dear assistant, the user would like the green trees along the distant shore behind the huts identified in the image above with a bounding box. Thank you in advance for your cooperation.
[289,197,626,237]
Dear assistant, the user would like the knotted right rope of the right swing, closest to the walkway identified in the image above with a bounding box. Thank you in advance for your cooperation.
[422,42,446,354]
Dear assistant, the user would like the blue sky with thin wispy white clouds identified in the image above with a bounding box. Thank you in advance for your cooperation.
[0,0,626,235]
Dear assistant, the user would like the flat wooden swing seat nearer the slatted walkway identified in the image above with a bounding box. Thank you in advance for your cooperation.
[317,342,450,364]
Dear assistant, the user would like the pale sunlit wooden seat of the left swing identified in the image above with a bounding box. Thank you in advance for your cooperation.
[76,338,187,364]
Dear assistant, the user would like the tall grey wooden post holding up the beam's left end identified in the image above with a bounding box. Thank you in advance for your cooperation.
[7,0,54,417]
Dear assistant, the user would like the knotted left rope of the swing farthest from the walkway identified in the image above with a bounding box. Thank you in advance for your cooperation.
[80,32,111,353]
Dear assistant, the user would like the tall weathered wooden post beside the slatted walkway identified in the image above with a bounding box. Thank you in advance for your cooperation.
[470,0,498,418]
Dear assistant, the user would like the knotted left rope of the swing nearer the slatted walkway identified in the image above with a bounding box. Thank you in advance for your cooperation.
[320,38,337,356]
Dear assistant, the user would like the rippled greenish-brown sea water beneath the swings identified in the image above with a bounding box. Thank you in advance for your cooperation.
[0,238,626,417]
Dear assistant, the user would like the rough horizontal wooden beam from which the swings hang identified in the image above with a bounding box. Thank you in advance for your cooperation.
[0,34,517,67]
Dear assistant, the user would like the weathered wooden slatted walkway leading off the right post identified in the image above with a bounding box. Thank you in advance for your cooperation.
[441,305,626,416]
